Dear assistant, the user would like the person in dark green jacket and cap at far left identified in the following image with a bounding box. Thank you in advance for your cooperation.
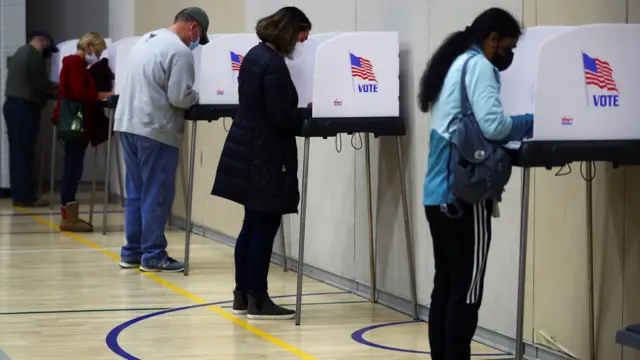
[2,31,58,207]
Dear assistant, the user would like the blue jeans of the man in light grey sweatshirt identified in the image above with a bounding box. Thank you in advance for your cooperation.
[119,132,180,266]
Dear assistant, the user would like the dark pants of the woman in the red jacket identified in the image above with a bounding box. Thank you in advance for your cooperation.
[60,139,89,205]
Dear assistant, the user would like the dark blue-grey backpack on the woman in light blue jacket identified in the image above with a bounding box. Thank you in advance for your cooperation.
[442,55,511,217]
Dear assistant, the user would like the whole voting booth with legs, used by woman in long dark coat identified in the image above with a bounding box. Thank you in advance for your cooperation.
[288,32,417,325]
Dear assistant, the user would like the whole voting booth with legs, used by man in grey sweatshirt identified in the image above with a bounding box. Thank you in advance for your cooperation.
[184,34,260,276]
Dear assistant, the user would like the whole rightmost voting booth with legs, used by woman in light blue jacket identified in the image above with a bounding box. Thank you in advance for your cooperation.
[501,24,640,359]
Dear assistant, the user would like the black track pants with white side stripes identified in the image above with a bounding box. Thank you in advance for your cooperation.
[425,203,493,360]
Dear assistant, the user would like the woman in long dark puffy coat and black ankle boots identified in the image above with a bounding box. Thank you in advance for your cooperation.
[211,7,311,319]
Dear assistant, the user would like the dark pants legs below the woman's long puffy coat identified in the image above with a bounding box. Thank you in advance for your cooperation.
[235,207,282,296]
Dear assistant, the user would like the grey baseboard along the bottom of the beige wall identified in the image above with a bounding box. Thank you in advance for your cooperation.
[171,215,571,360]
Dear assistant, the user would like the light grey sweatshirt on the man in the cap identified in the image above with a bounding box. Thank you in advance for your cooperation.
[114,29,198,147]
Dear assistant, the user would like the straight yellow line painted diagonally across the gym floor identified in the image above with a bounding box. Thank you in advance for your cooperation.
[14,206,316,360]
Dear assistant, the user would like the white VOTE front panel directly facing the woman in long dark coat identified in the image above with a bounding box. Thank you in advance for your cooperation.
[312,31,400,118]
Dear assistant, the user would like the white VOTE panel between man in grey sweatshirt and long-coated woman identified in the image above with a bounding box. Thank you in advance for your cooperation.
[198,34,260,105]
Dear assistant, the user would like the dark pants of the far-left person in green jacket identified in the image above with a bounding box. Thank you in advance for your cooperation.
[2,98,40,204]
